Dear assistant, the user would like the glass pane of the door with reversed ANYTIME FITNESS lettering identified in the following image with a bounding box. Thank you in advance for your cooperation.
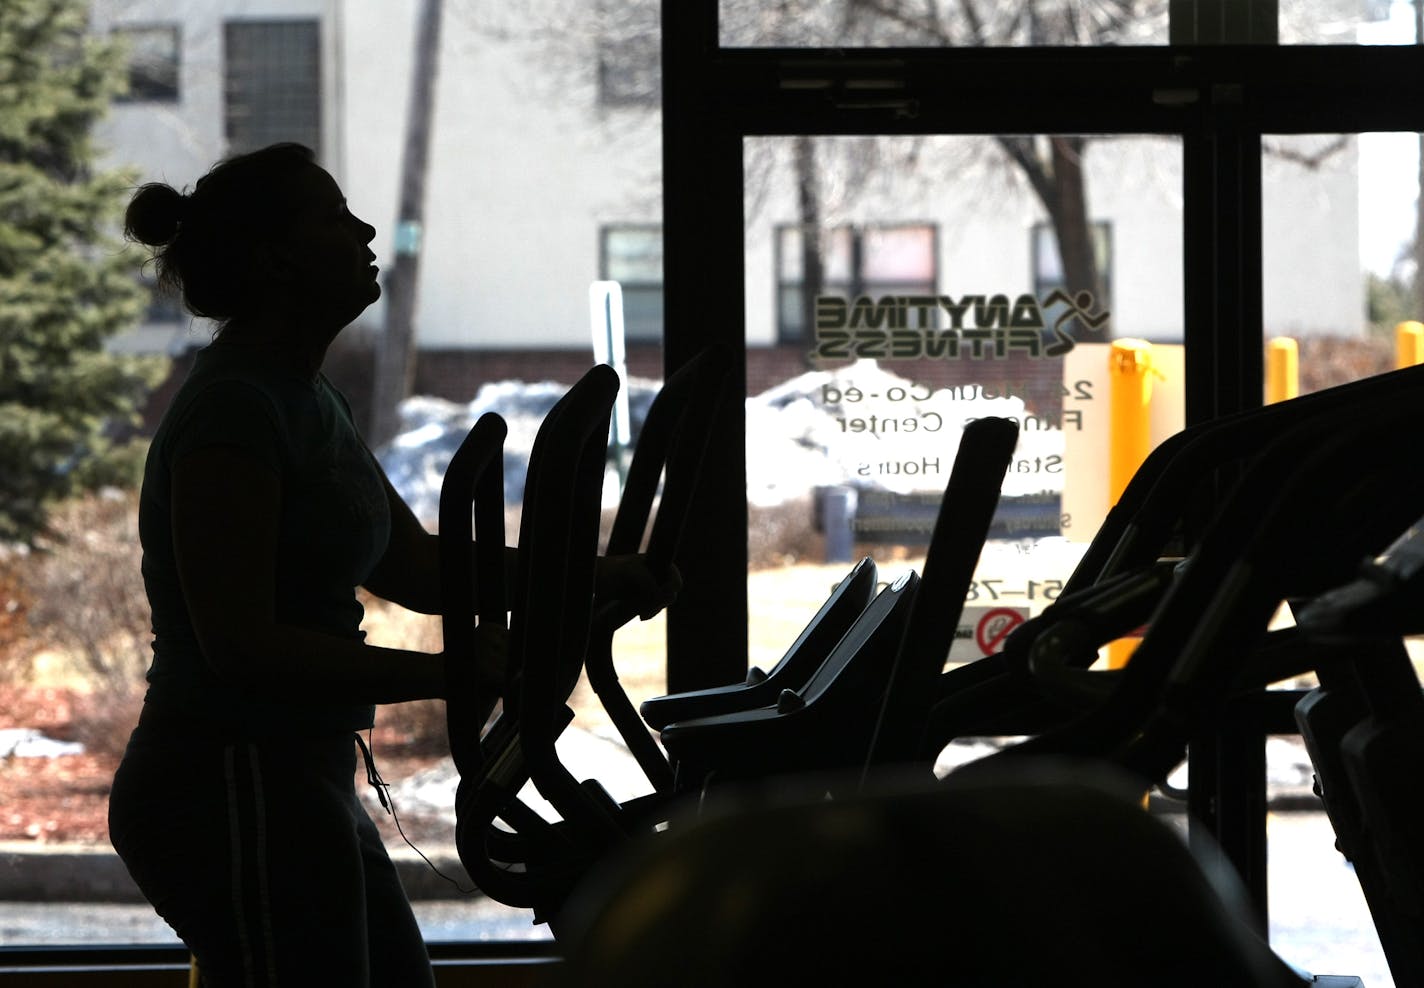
[743,134,1183,680]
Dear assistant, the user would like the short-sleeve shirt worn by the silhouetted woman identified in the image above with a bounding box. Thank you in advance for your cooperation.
[138,343,390,737]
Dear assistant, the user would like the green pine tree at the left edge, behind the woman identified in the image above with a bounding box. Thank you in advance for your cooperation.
[0,0,162,544]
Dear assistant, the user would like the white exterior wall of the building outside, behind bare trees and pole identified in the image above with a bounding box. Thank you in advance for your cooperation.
[93,0,1364,357]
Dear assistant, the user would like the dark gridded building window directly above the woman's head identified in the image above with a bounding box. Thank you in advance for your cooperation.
[224,20,322,154]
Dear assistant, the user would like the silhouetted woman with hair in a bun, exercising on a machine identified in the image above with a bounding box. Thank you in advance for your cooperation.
[110,144,672,988]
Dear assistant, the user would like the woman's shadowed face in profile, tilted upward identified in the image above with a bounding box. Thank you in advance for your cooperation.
[278,165,380,330]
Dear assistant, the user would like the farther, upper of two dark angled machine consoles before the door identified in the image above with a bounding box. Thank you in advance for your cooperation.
[638,557,879,730]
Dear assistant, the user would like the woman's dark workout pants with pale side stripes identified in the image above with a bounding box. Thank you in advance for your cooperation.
[108,715,434,988]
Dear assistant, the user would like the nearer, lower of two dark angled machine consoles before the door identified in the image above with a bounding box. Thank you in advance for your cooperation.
[661,571,920,789]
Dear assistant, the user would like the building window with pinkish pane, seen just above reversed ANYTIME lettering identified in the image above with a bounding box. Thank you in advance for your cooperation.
[776,224,938,343]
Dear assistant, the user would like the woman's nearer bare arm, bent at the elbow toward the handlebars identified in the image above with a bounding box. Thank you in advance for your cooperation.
[172,446,446,703]
